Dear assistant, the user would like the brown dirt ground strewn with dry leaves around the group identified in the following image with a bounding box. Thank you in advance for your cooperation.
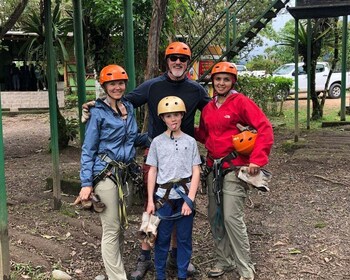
[2,97,350,280]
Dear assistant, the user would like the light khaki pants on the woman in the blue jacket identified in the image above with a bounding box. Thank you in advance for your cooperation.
[95,178,127,280]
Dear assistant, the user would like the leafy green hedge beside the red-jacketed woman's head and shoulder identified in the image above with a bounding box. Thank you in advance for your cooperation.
[236,76,293,116]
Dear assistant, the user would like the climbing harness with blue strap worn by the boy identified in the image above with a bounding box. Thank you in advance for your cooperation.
[155,177,195,220]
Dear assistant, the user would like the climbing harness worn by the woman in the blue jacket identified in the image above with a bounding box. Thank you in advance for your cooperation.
[93,154,142,229]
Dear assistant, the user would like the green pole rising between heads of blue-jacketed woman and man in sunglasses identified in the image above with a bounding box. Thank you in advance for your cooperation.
[124,0,136,92]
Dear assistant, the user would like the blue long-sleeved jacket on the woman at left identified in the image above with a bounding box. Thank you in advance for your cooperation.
[80,99,137,187]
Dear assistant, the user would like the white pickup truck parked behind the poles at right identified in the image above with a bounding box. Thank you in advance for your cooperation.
[272,62,350,98]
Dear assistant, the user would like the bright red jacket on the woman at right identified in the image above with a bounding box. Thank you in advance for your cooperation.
[195,92,273,168]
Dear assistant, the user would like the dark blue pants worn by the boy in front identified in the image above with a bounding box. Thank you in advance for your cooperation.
[154,198,193,279]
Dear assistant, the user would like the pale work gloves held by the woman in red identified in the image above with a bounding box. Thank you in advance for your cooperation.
[238,166,272,192]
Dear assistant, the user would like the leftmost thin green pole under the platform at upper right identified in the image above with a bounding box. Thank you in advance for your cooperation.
[294,19,299,142]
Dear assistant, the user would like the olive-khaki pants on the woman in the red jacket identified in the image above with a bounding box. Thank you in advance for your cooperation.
[208,172,255,278]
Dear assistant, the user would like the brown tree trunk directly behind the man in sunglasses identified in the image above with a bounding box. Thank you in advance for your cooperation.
[142,0,168,132]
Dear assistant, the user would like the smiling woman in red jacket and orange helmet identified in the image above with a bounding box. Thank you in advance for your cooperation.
[196,62,273,280]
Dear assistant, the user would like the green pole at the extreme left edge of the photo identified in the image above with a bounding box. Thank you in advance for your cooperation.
[0,92,10,280]
